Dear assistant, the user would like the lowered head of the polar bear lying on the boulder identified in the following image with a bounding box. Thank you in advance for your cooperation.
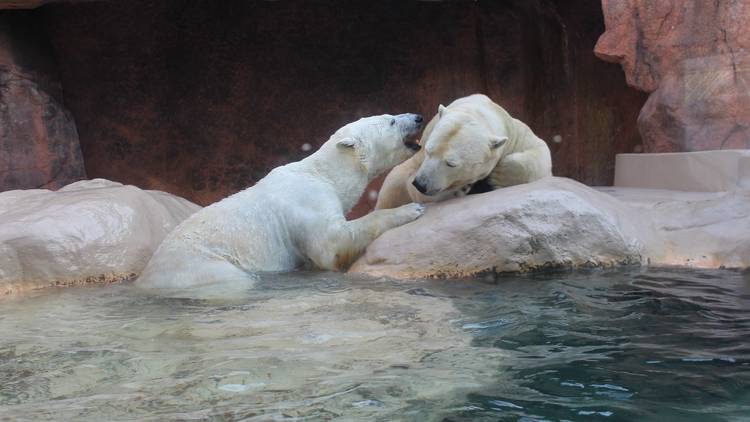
[412,105,508,196]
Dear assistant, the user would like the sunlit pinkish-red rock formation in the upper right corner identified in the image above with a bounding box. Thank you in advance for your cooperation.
[594,0,750,152]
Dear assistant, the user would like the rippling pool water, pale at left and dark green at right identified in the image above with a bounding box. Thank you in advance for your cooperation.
[0,268,750,422]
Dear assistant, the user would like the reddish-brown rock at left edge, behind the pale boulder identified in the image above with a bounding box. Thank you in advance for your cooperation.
[0,12,86,191]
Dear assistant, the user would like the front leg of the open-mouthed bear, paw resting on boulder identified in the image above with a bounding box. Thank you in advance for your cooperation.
[307,203,424,271]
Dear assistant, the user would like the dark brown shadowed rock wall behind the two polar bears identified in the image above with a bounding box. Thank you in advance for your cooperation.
[37,0,646,215]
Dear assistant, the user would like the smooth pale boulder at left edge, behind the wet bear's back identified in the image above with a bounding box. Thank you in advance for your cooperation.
[0,179,199,295]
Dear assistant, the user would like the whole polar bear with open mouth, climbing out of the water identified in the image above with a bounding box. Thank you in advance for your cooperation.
[136,114,423,289]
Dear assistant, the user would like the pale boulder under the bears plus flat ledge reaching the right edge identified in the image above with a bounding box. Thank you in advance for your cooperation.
[350,177,750,278]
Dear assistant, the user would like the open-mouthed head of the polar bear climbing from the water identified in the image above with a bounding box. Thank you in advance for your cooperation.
[333,113,422,177]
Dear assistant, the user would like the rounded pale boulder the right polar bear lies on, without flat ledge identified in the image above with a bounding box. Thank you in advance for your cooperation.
[350,177,648,278]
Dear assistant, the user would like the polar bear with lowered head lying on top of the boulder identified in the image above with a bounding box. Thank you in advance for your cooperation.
[375,94,552,209]
